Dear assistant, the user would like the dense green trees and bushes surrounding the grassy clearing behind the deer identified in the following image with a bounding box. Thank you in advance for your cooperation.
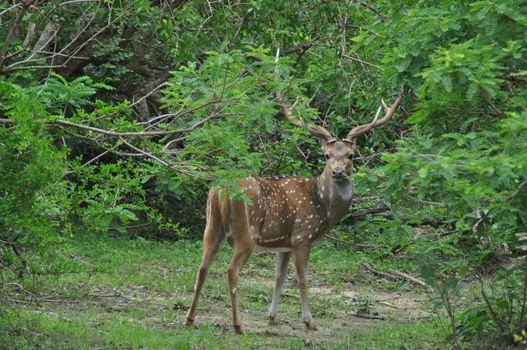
[0,0,527,348]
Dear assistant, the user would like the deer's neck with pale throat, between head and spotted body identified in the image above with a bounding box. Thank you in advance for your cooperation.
[317,170,353,228]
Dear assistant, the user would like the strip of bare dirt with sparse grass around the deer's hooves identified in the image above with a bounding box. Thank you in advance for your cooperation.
[6,247,433,347]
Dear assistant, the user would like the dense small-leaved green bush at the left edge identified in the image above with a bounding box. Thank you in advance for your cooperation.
[0,80,70,268]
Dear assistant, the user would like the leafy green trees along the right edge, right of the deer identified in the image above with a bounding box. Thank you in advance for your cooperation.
[368,1,527,346]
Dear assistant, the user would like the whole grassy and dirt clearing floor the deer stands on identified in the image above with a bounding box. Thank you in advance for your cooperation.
[0,234,448,349]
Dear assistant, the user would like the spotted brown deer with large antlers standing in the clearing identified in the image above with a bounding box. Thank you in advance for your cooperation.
[186,91,403,334]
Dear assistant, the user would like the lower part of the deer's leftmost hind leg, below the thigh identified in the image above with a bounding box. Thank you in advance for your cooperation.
[186,225,225,325]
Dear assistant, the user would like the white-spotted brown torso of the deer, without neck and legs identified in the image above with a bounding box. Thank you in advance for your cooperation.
[214,176,330,251]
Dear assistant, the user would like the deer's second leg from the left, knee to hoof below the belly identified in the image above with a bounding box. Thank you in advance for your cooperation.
[227,242,252,334]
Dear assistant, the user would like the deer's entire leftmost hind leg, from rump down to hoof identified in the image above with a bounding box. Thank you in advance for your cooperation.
[186,197,225,325]
